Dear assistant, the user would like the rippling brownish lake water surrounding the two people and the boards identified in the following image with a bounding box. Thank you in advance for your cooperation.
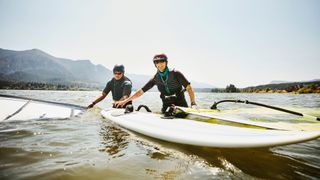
[0,90,320,179]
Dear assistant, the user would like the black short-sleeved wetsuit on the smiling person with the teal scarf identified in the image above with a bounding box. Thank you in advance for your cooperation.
[142,70,190,113]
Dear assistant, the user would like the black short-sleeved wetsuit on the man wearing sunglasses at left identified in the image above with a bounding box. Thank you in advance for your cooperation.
[103,76,132,107]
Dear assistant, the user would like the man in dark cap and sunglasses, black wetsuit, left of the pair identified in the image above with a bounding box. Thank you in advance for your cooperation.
[88,64,132,108]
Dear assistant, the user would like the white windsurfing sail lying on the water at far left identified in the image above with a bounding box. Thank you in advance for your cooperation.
[0,96,83,122]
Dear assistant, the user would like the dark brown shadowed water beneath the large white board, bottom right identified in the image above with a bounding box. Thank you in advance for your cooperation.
[184,147,320,179]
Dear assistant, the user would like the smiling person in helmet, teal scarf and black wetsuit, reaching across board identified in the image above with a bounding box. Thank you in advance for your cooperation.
[115,54,197,113]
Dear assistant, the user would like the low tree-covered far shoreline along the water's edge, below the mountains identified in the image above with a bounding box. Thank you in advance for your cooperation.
[0,81,320,94]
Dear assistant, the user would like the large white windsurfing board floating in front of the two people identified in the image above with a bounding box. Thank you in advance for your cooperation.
[101,109,320,148]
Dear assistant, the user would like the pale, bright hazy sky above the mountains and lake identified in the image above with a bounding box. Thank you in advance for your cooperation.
[0,0,320,87]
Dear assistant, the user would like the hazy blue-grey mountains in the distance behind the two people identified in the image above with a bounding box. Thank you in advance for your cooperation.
[0,48,213,89]
